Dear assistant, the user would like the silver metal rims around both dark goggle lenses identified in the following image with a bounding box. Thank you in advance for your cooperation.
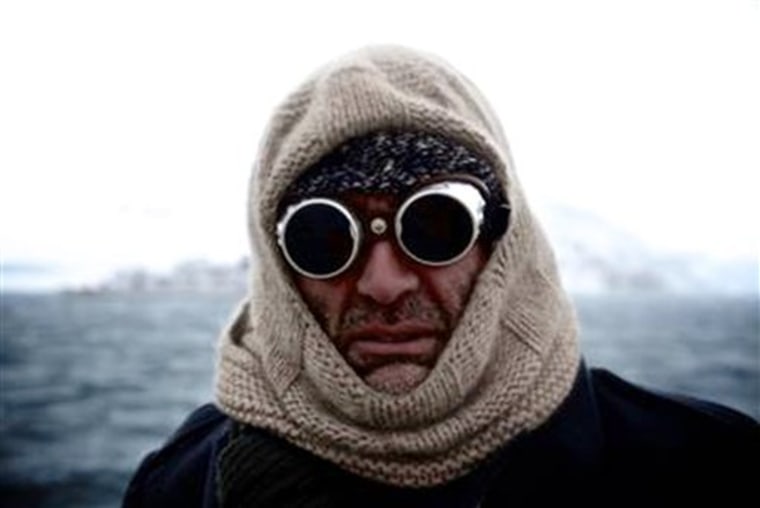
[277,181,486,279]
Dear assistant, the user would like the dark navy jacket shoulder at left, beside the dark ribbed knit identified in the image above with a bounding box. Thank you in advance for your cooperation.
[122,404,230,508]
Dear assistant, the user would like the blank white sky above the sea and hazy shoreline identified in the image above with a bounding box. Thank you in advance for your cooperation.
[0,0,760,286]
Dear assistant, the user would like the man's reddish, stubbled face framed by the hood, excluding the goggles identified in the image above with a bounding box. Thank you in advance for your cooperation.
[293,193,488,394]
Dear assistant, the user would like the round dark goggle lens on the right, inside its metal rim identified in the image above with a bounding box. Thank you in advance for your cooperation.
[401,194,473,263]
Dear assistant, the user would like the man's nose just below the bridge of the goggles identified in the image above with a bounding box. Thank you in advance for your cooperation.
[356,241,420,305]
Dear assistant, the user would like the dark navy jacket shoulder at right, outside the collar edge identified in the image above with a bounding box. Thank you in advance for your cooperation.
[592,370,760,502]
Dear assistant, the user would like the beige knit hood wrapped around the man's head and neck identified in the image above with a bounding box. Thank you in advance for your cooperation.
[216,46,579,487]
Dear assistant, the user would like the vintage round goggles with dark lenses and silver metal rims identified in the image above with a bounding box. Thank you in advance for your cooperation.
[277,180,506,279]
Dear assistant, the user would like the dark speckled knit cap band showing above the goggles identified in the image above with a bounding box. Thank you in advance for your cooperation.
[281,132,505,211]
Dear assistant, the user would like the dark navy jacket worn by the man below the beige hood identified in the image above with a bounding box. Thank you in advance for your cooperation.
[124,368,760,508]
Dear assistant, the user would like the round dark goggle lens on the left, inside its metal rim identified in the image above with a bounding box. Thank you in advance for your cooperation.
[284,203,354,275]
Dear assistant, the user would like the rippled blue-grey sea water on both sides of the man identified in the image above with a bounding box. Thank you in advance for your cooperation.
[0,294,760,508]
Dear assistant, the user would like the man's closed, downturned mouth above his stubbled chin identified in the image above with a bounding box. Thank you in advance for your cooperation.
[341,324,443,375]
